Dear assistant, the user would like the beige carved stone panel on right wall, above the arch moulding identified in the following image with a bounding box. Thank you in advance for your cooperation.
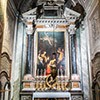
[88,2,100,58]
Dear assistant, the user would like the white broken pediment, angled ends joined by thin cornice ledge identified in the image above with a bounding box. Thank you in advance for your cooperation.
[22,7,80,24]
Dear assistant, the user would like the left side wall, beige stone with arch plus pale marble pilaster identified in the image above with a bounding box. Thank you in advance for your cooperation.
[0,0,27,100]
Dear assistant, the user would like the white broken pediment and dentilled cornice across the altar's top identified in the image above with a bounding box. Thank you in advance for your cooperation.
[22,6,80,34]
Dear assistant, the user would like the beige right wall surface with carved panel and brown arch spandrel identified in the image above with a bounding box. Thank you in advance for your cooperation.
[87,0,100,83]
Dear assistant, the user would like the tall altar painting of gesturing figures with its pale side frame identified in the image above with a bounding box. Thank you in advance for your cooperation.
[34,31,68,76]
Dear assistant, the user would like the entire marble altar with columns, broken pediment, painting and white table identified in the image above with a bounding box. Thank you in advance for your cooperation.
[20,2,83,100]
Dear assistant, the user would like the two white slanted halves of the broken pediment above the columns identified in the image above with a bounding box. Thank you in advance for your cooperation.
[23,7,80,23]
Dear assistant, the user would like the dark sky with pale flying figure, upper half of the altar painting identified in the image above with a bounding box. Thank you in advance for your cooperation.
[38,32,65,56]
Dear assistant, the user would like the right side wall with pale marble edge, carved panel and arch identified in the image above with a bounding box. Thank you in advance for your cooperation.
[82,0,100,100]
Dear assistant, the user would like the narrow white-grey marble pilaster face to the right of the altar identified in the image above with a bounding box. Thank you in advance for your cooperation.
[80,22,90,100]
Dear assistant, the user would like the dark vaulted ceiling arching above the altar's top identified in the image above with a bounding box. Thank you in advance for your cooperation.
[13,0,83,13]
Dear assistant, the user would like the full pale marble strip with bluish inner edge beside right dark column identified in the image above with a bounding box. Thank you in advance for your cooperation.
[76,25,90,100]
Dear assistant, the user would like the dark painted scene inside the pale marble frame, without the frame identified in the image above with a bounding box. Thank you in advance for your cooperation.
[37,32,65,75]
